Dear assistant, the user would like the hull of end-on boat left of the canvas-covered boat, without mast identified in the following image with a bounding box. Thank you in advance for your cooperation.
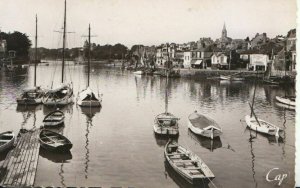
[153,112,179,136]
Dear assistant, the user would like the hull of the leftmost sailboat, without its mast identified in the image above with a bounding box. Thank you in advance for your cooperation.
[17,86,44,105]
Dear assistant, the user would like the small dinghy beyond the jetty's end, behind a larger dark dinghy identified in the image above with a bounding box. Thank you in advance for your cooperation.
[43,110,65,127]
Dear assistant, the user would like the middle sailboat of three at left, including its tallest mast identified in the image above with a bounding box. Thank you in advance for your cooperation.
[42,0,73,106]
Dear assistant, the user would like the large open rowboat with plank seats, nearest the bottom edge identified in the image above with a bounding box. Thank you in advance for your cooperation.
[164,141,215,185]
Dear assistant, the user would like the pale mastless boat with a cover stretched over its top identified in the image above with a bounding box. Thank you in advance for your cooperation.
[188,111,222,139]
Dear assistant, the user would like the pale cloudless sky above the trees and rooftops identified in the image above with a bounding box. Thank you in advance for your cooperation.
[0,0,297,48]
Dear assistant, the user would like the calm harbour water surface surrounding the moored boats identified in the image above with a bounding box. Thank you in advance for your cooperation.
[0,62,295,188]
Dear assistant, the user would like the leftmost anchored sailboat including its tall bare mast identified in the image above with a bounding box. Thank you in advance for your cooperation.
[17,16,44,105]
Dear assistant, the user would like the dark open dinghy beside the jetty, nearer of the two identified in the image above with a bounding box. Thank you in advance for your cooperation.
[39,129,73,152]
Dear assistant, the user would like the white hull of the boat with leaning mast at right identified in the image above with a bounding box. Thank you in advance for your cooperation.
[245,115,284,137]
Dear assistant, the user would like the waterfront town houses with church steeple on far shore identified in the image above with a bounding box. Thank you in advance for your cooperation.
[155,24,296,71]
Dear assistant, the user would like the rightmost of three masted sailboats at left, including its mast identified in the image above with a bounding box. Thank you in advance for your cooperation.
[77,25,102,107]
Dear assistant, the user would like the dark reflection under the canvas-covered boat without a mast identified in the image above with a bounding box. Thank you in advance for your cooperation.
[188,129,222,152]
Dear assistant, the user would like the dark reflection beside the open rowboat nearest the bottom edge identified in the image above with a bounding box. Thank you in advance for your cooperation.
[164,161,209,188]
